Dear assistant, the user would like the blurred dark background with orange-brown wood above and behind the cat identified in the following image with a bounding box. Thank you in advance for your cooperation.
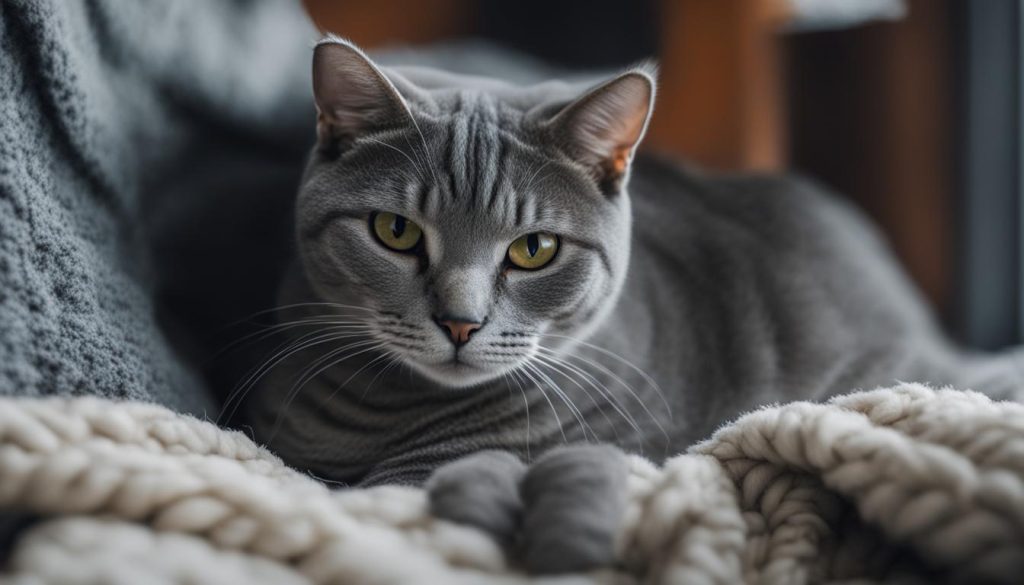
[305,0,1024,348]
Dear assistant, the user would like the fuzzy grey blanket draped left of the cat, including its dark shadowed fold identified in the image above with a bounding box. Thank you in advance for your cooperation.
[0,0,315,415]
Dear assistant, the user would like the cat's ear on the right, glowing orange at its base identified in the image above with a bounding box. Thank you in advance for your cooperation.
[549,66,655,194]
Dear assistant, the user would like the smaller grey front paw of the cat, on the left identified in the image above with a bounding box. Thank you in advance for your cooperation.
[426,451,526,548]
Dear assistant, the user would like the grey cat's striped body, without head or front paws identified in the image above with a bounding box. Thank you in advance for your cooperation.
[243,150,1015,484]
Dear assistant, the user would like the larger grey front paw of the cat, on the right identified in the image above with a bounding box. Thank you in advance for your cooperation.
[519,445,628,574]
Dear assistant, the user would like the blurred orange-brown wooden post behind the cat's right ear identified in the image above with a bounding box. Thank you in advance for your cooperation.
[647,0,786,170]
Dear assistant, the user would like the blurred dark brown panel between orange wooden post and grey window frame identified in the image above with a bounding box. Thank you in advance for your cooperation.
[785,0,958,318]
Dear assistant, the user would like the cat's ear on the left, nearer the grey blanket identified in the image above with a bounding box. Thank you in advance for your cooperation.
[313,37,411,149]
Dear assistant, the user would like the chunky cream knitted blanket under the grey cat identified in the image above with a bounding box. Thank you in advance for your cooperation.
[0,384,1024,585]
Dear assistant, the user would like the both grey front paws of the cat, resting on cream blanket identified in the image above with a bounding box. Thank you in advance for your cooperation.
[427,445,627,574]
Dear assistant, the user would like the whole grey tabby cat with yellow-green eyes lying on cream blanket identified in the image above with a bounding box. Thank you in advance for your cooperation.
[240,38,1020,572]
